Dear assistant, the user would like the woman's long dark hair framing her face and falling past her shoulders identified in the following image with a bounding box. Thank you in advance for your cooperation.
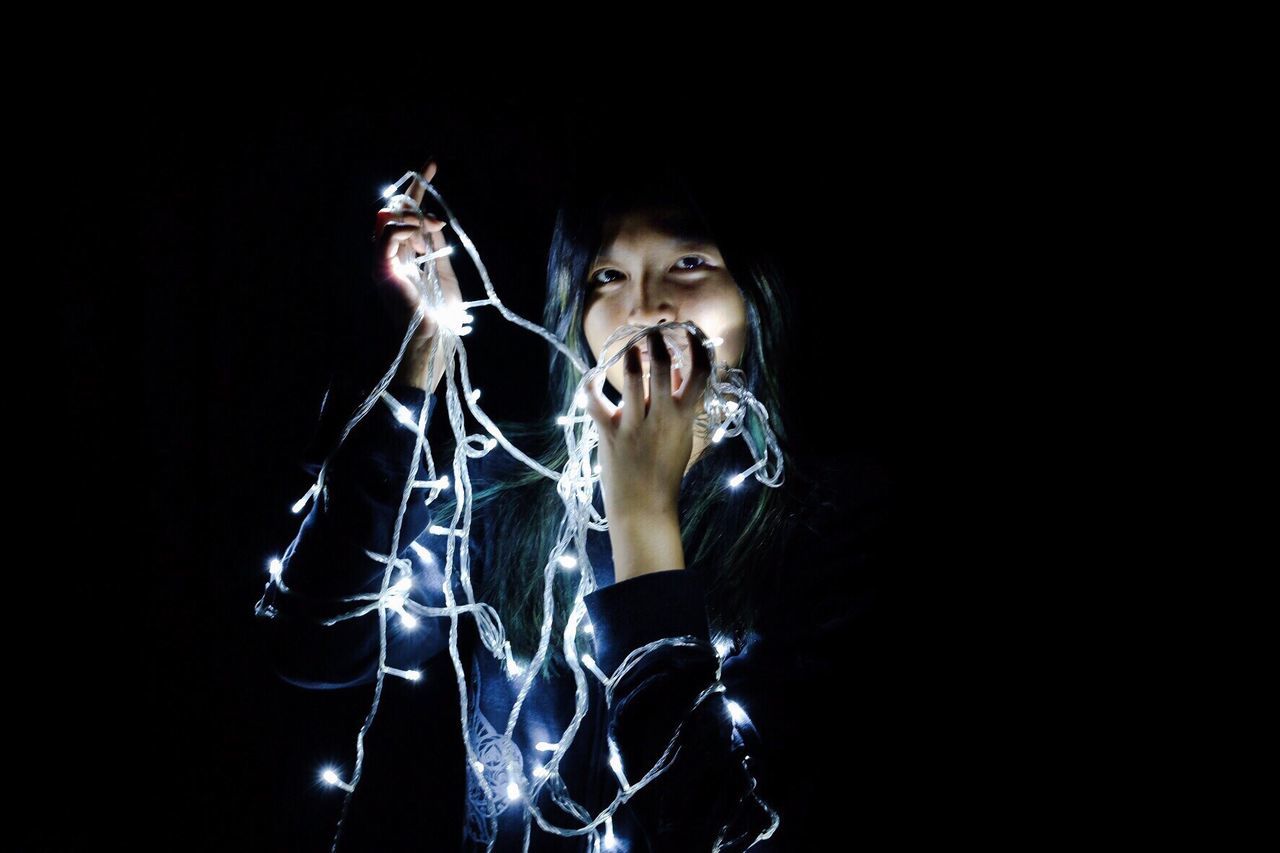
[445,149,799,674]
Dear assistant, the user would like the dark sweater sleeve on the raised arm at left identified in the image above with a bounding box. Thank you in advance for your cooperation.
[253,383,479,689]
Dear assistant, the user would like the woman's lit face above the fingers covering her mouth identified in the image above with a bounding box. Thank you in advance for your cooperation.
[582,207,746,393]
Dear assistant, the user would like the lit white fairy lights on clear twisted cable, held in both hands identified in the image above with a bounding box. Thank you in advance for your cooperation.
[257,172,783,850]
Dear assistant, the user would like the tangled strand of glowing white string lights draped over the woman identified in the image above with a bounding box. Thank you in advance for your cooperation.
[259,172,783,850]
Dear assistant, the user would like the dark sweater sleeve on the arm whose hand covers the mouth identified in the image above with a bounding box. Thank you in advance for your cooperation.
[586,569,772,853]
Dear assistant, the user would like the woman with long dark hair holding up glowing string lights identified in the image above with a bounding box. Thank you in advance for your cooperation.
[249,149,876,853]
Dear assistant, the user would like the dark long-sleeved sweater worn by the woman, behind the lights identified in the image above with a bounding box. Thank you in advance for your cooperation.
[256,384,892,853]
